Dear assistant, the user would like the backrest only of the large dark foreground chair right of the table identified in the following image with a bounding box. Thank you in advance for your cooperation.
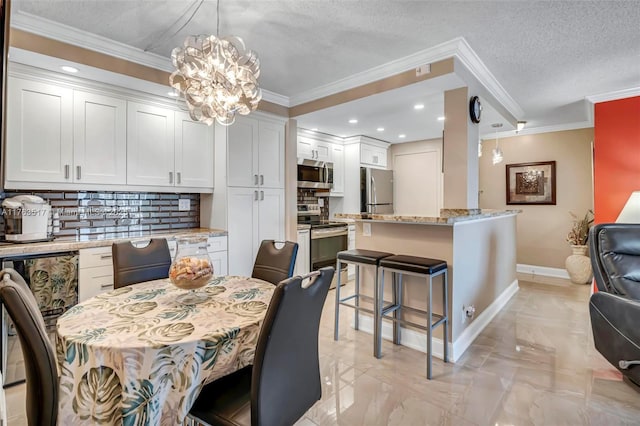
[251,267,334,425]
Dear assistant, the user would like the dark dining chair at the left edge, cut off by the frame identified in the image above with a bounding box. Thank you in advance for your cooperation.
[0,268,58,426]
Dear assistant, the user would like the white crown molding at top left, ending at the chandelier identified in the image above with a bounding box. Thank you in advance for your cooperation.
[11,11,173,72]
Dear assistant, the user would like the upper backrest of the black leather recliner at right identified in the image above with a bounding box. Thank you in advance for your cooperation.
[589,223,640,300]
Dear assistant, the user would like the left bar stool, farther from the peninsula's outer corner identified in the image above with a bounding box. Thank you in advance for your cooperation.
[333,249,393,355]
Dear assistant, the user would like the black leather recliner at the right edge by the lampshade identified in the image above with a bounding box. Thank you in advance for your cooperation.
[589,223,640,386]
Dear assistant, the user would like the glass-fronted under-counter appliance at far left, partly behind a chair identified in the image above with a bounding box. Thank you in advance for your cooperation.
[0,251,78,386]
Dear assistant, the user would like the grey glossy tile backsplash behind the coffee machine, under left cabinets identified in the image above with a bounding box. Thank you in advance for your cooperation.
[0,191,200,239]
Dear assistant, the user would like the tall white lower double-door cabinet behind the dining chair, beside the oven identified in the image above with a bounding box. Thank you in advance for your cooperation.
[227,187,284,276]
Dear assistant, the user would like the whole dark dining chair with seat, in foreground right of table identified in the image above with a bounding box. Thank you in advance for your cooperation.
[189,266,334,426]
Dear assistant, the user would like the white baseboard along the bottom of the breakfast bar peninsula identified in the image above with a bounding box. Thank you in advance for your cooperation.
[351,280,519,362]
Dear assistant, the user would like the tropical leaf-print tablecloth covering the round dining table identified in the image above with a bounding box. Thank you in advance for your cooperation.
[56,276,275,425]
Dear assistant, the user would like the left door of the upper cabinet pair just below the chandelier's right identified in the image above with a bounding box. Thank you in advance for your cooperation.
[227,117,260,186]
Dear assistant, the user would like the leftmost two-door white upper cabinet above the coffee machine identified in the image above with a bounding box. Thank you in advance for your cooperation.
[6,77,127,184]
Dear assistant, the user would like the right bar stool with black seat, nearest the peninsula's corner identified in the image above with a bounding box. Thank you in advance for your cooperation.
[374,255,449,380]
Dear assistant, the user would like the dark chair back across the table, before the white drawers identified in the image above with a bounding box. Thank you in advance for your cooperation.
[111,238,171,288]
